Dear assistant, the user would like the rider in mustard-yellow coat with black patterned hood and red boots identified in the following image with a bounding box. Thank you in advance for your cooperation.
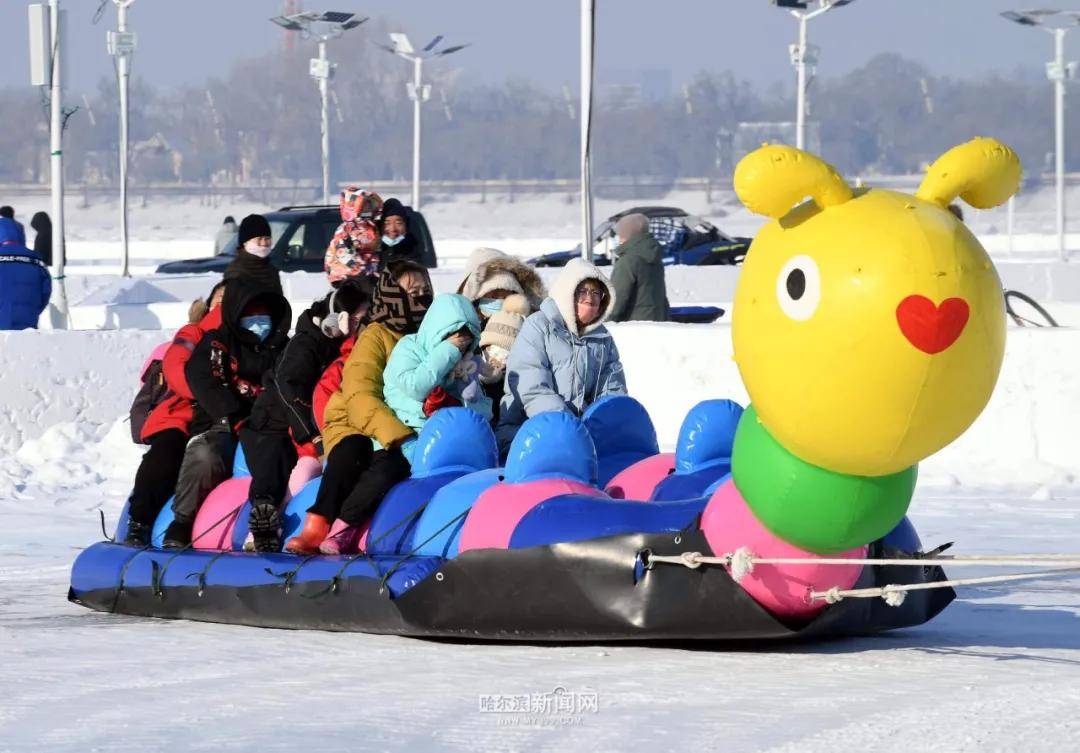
[285,261,432,553]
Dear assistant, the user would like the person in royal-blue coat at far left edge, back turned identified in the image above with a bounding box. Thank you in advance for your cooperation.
[0,217,53,330]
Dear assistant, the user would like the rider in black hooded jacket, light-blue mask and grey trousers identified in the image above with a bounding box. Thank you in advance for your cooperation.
[164,279,292,549]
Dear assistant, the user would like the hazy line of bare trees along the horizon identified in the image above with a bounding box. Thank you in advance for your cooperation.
[0,38,1080,184]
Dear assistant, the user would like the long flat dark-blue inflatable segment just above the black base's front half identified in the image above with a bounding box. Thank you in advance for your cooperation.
[510,494,708,549]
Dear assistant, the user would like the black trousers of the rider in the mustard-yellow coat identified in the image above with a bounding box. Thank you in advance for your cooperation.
[311,434,411,525]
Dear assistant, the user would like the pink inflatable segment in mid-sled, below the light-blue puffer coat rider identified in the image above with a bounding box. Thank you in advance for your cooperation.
[458,479,607,552]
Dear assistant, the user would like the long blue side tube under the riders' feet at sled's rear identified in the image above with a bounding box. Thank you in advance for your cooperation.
[71,542,443,596]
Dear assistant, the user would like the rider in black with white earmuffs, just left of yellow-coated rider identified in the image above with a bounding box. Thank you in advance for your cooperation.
[240,277,372,552]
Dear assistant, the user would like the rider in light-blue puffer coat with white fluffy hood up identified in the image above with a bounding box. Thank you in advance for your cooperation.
[495,259,626,456]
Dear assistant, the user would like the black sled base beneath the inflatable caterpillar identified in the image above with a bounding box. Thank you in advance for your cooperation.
[69,532,955,642]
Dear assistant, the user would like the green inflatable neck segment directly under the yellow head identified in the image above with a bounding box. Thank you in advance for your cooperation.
[731,405,918,554]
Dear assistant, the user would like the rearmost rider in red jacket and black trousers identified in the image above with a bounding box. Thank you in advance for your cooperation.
[124,281,225,547]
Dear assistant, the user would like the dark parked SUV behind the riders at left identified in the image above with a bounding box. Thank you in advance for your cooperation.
[158,205,438,274]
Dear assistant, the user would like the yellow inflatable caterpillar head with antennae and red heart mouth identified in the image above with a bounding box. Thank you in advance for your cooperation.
[732,138,1021,475]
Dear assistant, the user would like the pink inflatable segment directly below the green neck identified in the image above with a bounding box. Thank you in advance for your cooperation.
[701,480,866,619]
